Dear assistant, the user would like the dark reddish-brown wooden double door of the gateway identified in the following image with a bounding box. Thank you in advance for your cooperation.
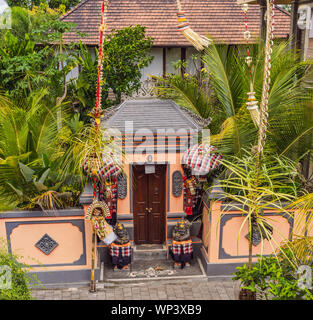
[133,165,166,244]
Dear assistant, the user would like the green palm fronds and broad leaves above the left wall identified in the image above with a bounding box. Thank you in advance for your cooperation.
[0,90,81,209]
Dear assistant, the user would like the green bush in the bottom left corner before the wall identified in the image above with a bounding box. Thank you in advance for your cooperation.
[0,240,39,300]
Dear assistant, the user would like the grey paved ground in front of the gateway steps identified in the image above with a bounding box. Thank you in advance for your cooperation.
[33,278,235,300]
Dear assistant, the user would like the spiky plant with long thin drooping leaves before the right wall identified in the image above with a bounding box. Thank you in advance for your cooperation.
[212,152,299,267]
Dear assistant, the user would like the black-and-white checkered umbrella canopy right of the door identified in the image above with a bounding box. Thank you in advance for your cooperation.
[182,144,223,175]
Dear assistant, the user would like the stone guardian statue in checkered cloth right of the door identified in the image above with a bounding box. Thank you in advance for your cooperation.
[171,219,193,269]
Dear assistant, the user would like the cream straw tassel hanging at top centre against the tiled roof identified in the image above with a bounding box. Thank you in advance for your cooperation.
[177,0,211,51]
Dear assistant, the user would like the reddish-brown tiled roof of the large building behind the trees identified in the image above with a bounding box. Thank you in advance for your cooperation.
[61,0,290,47]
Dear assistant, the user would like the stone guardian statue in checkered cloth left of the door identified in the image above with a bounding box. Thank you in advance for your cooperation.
[110,222,132,270]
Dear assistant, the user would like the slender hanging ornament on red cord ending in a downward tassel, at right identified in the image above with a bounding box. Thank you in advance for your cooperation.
[242,3,260,127]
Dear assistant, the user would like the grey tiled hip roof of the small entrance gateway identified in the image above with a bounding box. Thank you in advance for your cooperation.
[104,99,210,135]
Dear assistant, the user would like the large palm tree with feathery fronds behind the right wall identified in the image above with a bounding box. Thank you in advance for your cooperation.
[158,42,313,159]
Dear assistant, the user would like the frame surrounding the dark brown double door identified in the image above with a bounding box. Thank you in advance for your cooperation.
[129,161,170,243]
